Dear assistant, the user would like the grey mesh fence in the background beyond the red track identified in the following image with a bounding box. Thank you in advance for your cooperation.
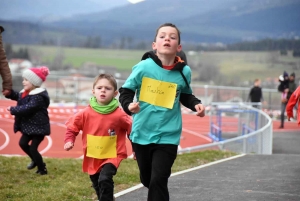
[2,73,281,111]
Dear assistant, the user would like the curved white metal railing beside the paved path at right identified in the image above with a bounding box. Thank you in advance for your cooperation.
[178,103,273,154]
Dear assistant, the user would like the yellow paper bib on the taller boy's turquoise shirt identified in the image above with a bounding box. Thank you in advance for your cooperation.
[140,77,177,109]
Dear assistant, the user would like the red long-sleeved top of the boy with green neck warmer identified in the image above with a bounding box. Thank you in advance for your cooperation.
[65,106,132,175]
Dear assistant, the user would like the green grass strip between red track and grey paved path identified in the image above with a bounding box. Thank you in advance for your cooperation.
[0,150,236,201]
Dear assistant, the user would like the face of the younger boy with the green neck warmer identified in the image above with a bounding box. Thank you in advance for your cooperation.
[92,78,118,105]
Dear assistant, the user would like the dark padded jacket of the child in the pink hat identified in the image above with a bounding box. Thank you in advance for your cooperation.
[6,88,50,135]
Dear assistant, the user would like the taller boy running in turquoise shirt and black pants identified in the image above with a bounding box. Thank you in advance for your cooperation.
[119,23,205,201]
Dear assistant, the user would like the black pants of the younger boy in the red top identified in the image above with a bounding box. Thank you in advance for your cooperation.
[90,163,117,201]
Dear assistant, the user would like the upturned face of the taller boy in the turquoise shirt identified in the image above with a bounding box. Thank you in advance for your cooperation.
[152,27,181,56]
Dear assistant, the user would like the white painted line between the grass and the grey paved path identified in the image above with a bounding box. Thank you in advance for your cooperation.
[114,154,246,198]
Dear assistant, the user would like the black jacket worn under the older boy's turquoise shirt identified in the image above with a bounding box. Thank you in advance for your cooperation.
[119,51,201,115]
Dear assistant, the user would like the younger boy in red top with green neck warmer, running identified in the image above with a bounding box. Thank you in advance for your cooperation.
[64,74,132,201]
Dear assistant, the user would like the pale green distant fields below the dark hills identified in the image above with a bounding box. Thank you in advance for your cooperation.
[14,45,300,81]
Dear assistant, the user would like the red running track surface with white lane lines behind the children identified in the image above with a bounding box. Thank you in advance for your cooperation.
[0,100,300,158]
